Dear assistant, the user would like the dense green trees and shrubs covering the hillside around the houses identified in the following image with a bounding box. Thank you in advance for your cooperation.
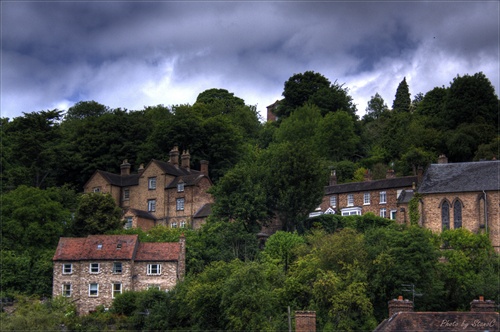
[0,71,500,331]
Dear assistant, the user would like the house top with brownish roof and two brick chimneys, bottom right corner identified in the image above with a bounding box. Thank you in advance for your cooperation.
[374,296,500,332]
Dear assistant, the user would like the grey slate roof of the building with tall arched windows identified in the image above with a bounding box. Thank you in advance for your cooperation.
[418,160,500,194]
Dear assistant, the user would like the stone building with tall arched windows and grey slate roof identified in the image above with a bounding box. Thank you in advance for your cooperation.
[418,156,500,252]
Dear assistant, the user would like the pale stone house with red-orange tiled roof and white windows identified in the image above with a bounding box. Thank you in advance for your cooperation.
[52,235,186,314]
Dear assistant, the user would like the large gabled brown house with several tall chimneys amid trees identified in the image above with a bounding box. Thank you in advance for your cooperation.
[84,147,213,230]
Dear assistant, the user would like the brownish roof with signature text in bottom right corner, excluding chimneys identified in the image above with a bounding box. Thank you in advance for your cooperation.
[375,312,500,332]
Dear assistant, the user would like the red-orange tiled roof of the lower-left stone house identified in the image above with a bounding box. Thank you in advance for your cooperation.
[52,234,180,261]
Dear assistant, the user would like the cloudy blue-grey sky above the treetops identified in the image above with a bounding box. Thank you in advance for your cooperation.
[0,0,500,118]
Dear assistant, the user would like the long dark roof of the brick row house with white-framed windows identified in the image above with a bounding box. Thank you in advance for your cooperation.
[325,176,418,195]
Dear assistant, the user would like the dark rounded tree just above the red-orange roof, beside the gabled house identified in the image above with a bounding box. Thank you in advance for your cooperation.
[73,193,124,237]
